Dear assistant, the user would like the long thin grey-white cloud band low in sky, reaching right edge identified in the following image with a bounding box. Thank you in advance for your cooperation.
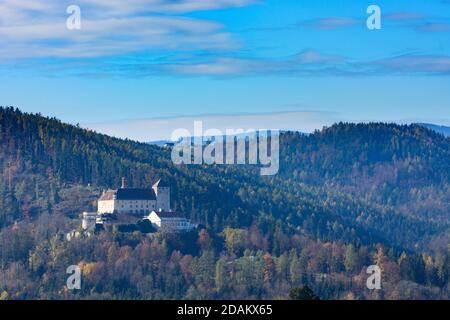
[104,50,450,78]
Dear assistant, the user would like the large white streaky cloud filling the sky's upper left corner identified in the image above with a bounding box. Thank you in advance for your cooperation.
[0,0,256,60]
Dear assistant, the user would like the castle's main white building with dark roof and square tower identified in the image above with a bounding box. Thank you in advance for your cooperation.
[97,178,171,215]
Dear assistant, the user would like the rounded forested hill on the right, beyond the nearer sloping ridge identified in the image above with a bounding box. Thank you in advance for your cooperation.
[280,123,450,245]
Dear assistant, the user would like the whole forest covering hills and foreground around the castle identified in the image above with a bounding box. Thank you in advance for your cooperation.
[0,108,450,299]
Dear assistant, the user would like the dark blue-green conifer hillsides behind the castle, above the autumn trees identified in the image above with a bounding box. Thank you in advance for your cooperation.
[0,108,450,249]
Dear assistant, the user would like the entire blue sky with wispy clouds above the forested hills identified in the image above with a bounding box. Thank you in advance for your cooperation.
[0,0,450,141]
